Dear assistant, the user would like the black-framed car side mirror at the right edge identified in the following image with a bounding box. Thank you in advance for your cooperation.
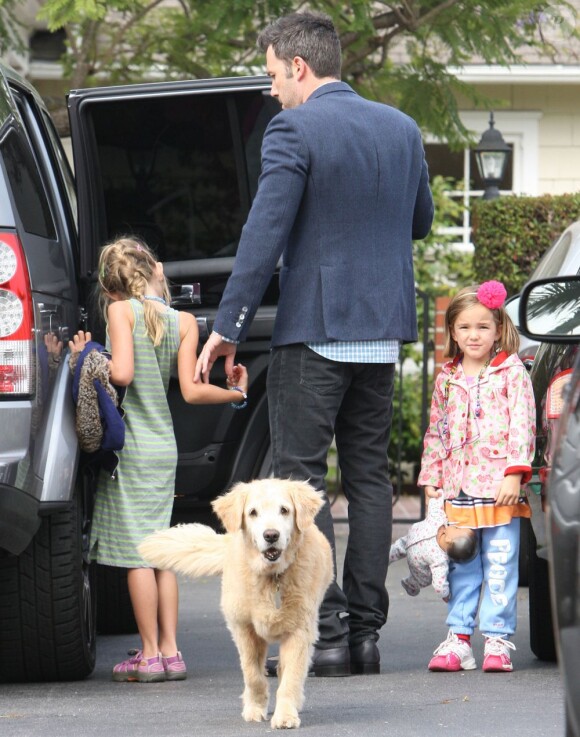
[519,275,580,343]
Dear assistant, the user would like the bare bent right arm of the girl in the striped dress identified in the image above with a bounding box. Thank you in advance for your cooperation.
[177,312,248,404]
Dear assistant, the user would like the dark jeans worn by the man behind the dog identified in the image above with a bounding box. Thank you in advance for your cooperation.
[267,344,395,648]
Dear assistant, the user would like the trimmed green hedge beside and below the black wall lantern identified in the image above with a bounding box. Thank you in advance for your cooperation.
[471,194,580,296]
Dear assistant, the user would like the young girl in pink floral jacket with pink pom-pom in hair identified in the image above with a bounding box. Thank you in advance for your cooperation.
[418,281,536,672]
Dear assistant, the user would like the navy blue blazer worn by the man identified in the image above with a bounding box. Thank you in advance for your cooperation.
[214,82,433,346]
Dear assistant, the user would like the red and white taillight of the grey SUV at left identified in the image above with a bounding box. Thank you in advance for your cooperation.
[0,232,34,396]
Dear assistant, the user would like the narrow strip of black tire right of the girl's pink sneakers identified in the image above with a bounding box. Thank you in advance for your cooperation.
[528,525,556,662]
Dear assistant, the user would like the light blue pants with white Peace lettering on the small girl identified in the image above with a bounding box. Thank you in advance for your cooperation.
[447,517,520,635]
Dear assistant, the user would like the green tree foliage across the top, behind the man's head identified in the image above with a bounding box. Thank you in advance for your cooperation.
[29,0,580,146]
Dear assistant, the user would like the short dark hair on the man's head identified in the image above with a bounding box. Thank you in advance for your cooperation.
[258,13,342,79]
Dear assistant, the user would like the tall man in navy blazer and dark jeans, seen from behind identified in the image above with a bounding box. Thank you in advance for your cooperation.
[196,13,433,676]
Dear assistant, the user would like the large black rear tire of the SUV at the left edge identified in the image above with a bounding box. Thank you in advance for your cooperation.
[0,488,96,683]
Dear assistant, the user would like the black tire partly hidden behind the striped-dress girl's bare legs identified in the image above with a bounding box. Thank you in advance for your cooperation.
[97,565,137,635]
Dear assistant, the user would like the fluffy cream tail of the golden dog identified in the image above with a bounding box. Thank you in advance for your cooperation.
[137,523,228,578]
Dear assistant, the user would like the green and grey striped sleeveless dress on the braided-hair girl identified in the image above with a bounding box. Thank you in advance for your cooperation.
[90,299,179,568]
